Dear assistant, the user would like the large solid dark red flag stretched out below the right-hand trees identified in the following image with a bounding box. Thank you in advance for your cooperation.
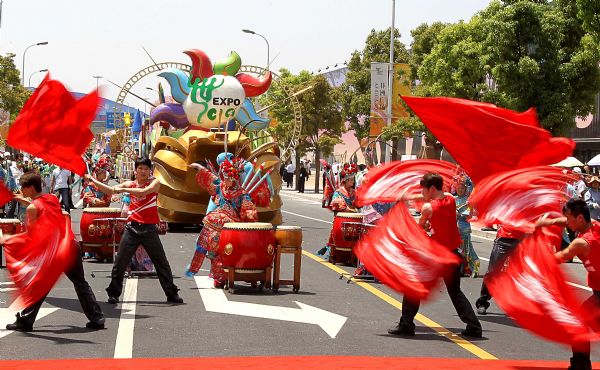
[402,96,575,183]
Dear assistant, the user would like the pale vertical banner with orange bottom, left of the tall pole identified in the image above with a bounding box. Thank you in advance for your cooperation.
[369,62,390,137]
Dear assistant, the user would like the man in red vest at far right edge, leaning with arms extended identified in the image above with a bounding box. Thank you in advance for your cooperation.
[537,199,600,370]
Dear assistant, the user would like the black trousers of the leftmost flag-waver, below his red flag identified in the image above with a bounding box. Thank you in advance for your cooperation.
[17,249,104,326]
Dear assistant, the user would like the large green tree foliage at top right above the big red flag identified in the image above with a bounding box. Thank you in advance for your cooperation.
[417,0,600,134]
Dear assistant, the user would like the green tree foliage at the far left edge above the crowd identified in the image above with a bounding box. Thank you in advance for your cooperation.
[0,54,30,121]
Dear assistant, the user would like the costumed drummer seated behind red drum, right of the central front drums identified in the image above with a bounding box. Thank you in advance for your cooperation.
[317,163,358,259]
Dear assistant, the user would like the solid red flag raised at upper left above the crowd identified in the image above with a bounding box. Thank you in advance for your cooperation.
[8,74,100,176]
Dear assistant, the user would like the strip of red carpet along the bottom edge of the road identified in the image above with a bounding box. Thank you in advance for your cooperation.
[0,356,588,370]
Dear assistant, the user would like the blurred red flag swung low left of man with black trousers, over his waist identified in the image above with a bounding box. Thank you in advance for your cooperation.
[354,203,460,299]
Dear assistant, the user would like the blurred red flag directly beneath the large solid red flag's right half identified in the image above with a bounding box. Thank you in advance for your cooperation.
[469,166,575,233]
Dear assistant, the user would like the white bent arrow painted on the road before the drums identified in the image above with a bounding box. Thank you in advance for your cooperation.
[195,276,347,338]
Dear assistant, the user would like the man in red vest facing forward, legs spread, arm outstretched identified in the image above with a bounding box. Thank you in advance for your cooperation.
[86,158,183,304]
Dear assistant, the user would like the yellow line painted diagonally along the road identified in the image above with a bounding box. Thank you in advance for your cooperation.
[302,250,498,360]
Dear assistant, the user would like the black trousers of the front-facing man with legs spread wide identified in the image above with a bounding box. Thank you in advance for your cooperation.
[106,222,179,297]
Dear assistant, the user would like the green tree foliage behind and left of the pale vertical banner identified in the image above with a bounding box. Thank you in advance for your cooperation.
[337,28,408,139]
